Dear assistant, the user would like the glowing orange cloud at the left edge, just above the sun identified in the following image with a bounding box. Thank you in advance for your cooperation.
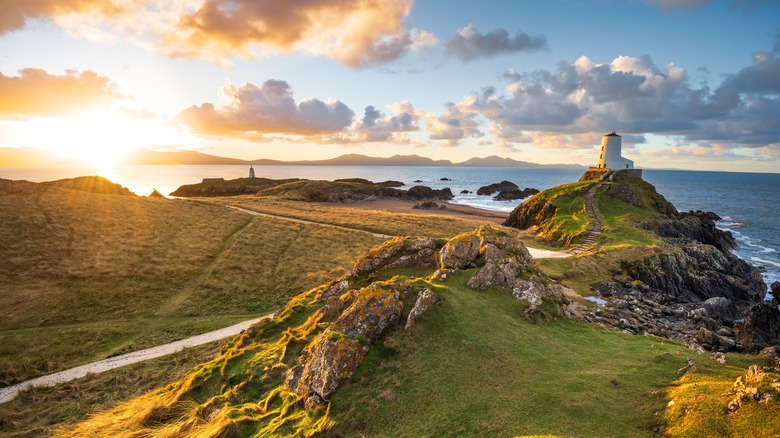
[0,68,122,119]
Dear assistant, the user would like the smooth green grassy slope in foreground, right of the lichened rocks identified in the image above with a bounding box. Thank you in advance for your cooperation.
[326,275,691,437]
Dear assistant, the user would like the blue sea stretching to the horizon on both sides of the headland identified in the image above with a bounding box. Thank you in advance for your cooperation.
[0,165,780,296]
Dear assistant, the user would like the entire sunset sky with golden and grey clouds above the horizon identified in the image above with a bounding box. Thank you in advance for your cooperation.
[0,0,780,173]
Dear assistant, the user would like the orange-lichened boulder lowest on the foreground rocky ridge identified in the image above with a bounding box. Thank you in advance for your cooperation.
[285,331,368,404]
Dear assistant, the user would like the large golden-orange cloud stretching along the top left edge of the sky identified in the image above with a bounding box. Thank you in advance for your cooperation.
[6,0,436,67]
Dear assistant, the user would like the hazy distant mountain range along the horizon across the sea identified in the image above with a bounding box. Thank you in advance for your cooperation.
[0,148,585,169]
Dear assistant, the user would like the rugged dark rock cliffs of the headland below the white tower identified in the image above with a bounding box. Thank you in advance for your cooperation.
[505,171,768,352]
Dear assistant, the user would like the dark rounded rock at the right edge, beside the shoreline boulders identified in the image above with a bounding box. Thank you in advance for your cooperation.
[734,303,780,352]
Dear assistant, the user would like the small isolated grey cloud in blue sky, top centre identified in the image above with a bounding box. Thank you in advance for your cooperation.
[444,24,548,62]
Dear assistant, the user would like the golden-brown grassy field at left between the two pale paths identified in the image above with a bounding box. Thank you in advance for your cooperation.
[0,189,379,385]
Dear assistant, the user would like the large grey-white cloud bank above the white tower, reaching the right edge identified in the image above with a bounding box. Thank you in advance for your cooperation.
[442,52,780,150]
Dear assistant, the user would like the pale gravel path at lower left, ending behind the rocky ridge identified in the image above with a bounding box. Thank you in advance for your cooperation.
[0,313,273,403]
